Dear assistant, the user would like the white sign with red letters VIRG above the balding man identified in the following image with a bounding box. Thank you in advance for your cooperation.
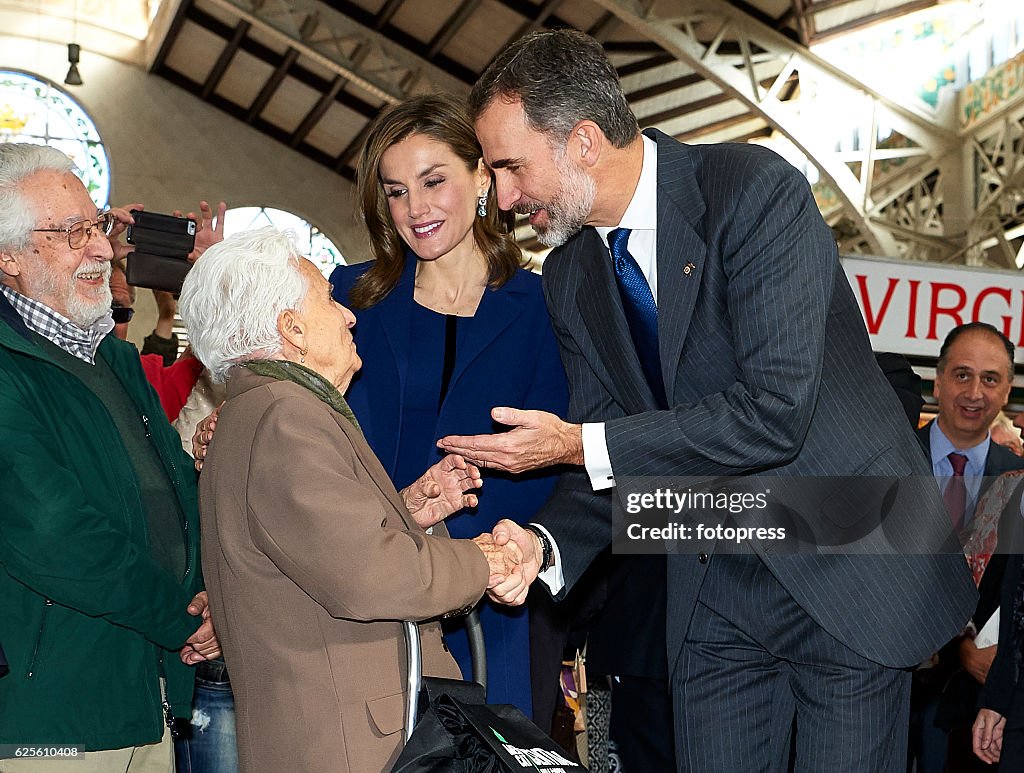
[842,257,1024,362]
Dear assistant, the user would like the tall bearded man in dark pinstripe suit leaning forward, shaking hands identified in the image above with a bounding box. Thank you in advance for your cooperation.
[440,31,976,773]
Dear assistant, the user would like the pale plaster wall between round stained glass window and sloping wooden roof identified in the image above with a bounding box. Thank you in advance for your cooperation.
[0,35,370,343]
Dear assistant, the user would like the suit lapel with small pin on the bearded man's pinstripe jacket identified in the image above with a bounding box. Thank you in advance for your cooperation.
[648,131,708,405]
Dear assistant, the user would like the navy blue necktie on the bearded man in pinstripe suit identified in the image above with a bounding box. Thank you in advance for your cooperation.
[608,228,669,409]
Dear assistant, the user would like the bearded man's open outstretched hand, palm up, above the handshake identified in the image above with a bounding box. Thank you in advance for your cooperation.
[437,407,583,473]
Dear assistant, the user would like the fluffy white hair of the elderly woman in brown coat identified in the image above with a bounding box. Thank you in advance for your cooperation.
[178,226,308,382]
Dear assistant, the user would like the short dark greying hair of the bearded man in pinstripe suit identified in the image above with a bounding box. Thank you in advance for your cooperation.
[469,30,640,147]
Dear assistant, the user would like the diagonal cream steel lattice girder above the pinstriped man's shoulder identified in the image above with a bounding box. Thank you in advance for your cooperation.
[591,0,963,259]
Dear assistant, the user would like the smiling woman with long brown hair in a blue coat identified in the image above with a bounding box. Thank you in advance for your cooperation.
[331,95,567,716]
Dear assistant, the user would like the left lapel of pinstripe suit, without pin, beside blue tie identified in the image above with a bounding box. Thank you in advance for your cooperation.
[577,228,654,413]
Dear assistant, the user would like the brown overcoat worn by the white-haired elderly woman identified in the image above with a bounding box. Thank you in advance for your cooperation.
[200,368,487,773]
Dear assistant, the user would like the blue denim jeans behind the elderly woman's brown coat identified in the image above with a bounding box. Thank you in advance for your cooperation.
[174,659,239,773]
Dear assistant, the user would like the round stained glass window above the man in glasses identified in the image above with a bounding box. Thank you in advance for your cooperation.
[0,70,111,209]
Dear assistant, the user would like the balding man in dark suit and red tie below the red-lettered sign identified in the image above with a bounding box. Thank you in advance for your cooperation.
[910,323,1024,773]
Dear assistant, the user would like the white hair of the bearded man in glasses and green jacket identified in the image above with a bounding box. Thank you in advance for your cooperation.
[0,142,75,251]
